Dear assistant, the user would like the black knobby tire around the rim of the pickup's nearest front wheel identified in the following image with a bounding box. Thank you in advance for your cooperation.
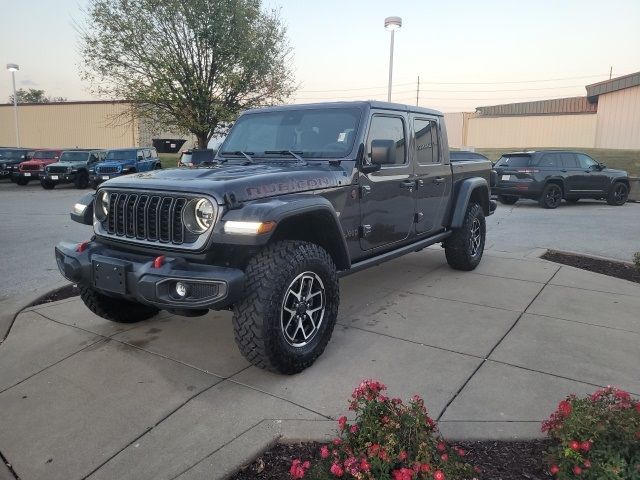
[233,240,340,374]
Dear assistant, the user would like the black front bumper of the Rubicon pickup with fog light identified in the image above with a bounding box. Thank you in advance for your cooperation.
[55,242,245,310]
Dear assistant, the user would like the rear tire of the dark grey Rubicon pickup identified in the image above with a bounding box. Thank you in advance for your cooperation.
[444,203,487,271]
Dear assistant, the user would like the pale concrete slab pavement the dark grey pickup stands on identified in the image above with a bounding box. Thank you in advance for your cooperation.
[0,248,640,480]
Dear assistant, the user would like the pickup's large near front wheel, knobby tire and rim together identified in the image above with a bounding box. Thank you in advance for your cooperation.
[233,240,340,374]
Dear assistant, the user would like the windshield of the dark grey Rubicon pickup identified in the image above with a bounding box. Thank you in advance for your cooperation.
[219,108,360,158]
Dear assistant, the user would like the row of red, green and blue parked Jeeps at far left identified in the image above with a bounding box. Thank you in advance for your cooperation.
[0,148,162,190]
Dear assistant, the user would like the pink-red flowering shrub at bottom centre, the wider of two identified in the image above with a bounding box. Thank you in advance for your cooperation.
[290,380,475,480]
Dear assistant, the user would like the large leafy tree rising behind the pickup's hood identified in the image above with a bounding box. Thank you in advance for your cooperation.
[80,0,295,148]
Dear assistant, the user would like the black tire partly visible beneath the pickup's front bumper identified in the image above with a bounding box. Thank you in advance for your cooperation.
[80,286,160,323]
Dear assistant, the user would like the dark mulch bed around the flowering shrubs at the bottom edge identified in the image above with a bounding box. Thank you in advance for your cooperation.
[231,440,552,480]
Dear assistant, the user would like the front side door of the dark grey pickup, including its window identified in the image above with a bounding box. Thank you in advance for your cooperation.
[360,114,415,250]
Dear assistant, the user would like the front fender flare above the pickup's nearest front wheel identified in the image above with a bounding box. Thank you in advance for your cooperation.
[213,194,351,270]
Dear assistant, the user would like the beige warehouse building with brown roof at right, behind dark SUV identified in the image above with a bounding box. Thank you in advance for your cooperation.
[445,72,640,150]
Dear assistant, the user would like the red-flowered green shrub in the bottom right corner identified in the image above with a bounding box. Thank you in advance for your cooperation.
[542,387,640,480]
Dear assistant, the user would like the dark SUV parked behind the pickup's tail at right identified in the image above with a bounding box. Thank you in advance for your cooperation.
[491,150,629,208]
